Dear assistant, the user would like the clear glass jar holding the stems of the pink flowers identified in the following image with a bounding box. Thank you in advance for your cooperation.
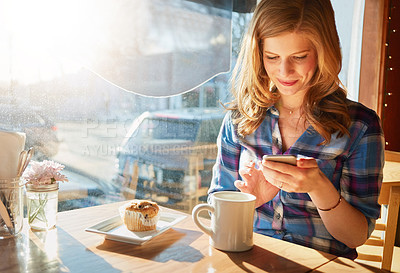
[26,182,58,230]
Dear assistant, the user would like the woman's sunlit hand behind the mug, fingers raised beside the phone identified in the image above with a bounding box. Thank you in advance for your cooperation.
[235,161,279,208]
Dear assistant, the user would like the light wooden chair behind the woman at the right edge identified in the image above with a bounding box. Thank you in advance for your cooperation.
[356,151,400,270]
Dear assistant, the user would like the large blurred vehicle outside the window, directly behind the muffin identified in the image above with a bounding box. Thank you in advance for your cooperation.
[113,108,224,210]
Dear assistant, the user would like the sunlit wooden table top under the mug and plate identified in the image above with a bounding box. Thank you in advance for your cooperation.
[0,202,388,273]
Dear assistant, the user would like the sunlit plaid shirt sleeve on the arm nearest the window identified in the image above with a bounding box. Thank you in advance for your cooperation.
[208,112,241,194]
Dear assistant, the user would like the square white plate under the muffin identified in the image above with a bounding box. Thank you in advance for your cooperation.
[85,212,187,245]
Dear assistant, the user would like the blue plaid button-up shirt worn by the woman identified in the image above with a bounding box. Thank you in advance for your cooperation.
[209,100,384,259]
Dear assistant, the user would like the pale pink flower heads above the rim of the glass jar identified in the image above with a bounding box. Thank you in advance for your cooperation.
[23,160,68,186]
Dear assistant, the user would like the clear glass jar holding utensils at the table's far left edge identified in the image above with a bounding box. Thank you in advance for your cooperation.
[0,177,24,239]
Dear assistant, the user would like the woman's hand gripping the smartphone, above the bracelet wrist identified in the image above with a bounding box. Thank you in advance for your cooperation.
[261,158,329,193]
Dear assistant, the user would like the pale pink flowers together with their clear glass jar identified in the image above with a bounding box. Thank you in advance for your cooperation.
[23,160,68,230]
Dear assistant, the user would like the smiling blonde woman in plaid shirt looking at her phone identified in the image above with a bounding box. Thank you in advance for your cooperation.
[209,0,384,259]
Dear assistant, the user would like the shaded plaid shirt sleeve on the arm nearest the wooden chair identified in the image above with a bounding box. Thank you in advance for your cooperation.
[341,106,384,236]
